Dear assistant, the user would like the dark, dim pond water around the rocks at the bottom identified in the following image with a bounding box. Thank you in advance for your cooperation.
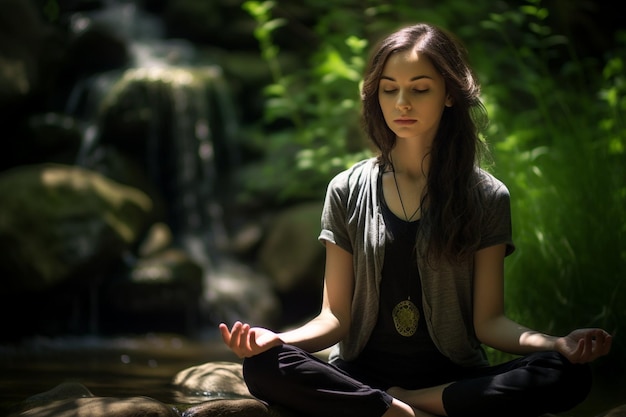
[0,331,626,417]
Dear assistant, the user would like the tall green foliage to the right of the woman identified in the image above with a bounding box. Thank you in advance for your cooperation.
[476,0,626,367]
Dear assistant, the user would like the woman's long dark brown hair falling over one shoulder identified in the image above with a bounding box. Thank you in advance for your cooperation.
[361,23,487,261]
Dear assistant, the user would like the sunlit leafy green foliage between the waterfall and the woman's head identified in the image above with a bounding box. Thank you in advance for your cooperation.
[235,1,369,202]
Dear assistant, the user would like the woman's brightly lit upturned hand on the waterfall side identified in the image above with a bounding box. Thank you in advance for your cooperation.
[219,321,283,358]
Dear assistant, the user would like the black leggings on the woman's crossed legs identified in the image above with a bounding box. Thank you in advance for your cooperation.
[243,345,591,417]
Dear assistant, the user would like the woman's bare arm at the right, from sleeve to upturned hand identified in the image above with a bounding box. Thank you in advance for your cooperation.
[474,245,611,362]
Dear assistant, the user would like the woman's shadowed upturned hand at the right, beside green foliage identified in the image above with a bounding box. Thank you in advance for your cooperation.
[555,329,613,363]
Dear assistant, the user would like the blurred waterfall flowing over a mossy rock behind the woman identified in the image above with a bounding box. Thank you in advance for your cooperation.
[66,0,238,276]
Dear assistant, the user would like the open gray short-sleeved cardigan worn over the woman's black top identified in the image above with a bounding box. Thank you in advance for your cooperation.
[319,158,514,366]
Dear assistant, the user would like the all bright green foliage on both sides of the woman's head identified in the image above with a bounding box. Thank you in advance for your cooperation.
[240,0,626,370]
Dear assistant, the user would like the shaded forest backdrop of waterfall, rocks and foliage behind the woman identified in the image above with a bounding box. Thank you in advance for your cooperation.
[0,0,626,415]
